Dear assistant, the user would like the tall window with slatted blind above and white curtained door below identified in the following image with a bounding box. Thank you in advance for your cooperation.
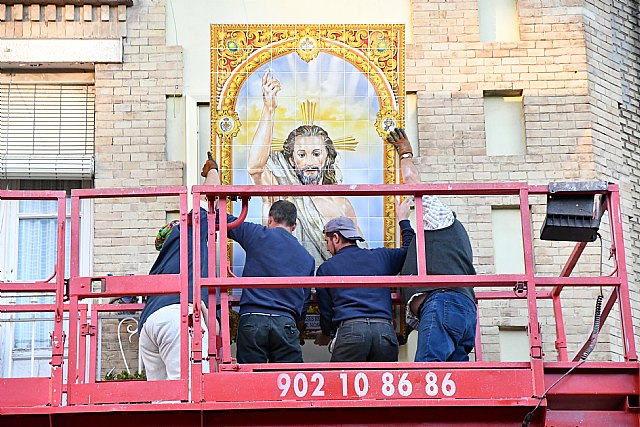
[0,72,95,377]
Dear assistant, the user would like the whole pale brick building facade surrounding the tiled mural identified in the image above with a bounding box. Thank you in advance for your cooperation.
[0,0,640,376]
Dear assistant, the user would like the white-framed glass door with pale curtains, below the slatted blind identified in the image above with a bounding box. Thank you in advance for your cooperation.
[0,180,92,377]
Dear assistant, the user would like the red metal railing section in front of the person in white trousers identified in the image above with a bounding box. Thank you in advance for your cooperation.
[67,187,189,405]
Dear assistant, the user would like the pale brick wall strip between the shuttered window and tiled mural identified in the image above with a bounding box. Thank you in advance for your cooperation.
[94,0,183,274]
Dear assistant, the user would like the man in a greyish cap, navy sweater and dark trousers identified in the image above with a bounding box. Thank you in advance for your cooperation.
[316,200,415,362]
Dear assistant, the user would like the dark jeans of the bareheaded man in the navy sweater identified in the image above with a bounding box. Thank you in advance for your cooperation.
[236,313,302,363]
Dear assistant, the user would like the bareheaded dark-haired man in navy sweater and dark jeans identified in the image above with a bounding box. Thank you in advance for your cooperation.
[227,200,315,363]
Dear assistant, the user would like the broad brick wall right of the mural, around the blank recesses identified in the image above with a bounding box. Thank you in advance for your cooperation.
[407,0,624,360]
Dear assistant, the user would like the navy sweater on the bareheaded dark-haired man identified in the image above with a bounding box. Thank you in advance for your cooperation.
[227,215,315,320]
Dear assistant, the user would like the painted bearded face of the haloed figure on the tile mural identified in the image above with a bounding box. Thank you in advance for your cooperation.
[293,136,327,185]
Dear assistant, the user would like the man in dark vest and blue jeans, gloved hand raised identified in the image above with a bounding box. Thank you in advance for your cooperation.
[387,129,477,362]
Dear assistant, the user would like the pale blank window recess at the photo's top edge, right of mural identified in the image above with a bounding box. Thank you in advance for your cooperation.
[478,0,520,42]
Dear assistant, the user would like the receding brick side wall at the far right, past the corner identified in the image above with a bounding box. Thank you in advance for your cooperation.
[584,1,640,358]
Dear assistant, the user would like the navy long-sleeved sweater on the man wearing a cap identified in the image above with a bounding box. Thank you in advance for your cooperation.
[316,220,415,335]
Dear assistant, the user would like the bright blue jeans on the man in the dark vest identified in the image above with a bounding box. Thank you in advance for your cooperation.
[415,290,477,362]
